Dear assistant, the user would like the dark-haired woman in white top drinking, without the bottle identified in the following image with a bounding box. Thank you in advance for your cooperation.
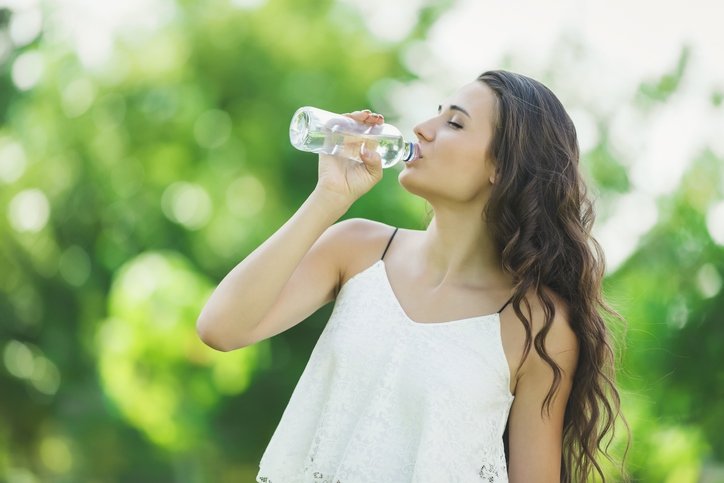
[197,71,628,483]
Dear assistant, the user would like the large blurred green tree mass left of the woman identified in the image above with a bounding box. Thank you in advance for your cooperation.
[0,0,424,481]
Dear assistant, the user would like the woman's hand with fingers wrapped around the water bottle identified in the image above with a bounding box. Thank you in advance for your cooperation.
[315,109,384,205]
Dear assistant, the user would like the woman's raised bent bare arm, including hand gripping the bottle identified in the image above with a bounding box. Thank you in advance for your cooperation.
[196,111,383,351]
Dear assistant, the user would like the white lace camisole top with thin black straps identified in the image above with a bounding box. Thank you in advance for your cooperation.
[256,230,514,483]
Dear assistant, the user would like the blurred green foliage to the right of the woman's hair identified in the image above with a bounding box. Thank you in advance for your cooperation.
[607,151,724,482]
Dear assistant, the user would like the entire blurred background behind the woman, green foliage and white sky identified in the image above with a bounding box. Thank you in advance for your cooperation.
[0,0,724,483]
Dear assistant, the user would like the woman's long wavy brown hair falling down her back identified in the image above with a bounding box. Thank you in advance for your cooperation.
[477,70,631,483]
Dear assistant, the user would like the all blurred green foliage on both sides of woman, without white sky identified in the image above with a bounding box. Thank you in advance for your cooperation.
[0,0,724,482]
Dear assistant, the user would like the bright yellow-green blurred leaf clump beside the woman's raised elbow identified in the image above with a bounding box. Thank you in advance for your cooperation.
[96,251,258,450]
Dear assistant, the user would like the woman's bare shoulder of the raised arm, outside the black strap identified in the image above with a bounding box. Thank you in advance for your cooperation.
[334,218,395,287]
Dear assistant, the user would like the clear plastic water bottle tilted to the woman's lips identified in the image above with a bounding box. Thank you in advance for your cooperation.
[289,106,420,168]
